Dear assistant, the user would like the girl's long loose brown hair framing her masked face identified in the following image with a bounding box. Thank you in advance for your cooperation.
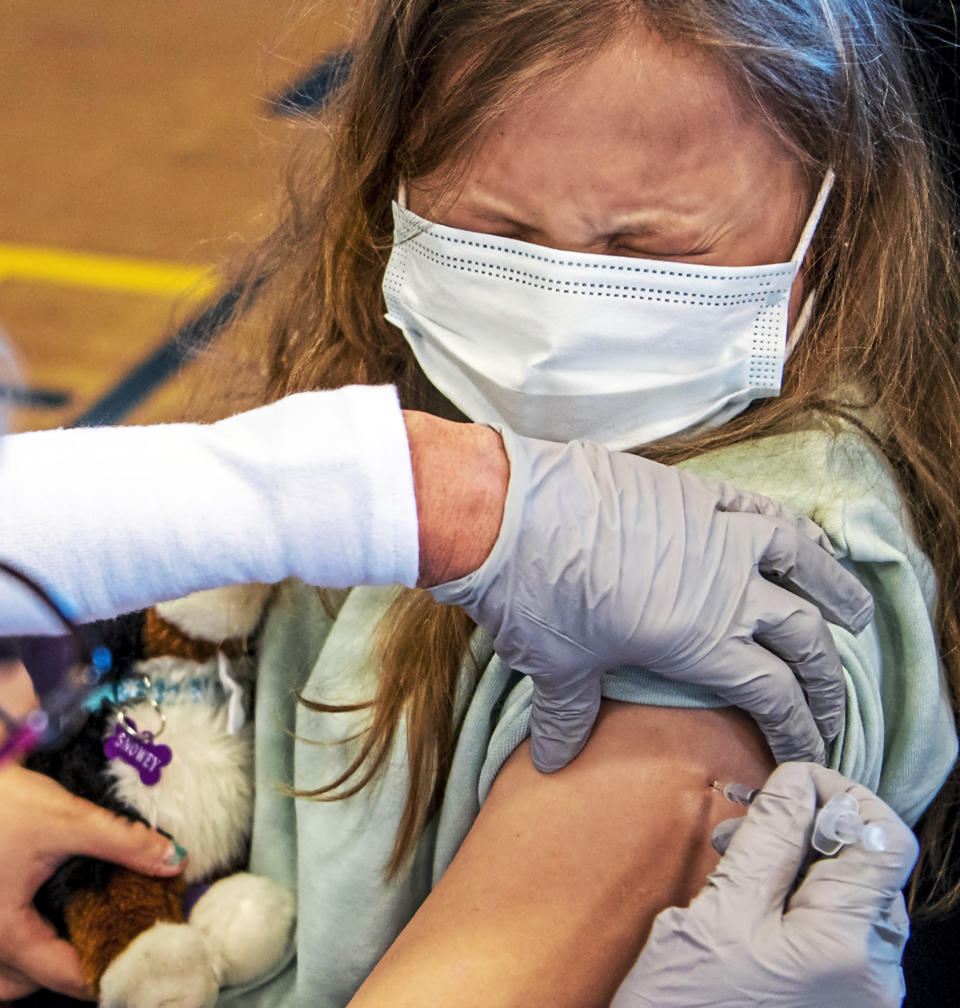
[207,0,960,908]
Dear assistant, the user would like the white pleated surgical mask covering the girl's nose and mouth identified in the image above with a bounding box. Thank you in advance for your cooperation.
[383,171,834,449]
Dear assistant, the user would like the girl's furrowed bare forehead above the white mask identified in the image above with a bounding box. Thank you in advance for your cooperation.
[417,33,803,261]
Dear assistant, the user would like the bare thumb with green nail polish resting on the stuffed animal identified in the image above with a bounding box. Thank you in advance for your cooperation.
[66,798,187,875]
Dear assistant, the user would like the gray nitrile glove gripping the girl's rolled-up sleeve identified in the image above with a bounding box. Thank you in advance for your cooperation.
[432,429,873,771]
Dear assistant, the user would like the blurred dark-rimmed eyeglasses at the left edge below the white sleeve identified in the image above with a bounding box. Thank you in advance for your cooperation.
[0,561,113,764]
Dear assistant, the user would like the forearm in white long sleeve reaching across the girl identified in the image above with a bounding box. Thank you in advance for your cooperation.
[0,386,418,634]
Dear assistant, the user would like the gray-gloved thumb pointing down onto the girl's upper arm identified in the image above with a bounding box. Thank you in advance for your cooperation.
[530,672,601,773]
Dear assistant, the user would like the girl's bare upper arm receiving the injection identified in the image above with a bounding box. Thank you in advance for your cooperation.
[351,702,773,1008]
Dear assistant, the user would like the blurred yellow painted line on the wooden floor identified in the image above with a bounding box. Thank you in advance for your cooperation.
[0,243,217,298]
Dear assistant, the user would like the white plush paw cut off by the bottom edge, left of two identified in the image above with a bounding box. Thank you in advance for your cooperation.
[100,923,220,1008]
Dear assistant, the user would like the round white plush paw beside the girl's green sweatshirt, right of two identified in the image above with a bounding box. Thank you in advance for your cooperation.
[190,872,295,986]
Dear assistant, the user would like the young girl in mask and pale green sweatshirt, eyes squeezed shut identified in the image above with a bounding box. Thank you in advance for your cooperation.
[155,0,960,1005]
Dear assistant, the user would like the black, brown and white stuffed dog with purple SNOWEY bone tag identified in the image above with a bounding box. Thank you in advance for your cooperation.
[27,585,294,1008]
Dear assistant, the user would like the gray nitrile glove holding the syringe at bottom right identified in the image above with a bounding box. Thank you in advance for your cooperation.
[611,763,917,1008]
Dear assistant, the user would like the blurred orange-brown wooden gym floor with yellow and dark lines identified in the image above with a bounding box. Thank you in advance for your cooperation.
[0,0,349,429]
